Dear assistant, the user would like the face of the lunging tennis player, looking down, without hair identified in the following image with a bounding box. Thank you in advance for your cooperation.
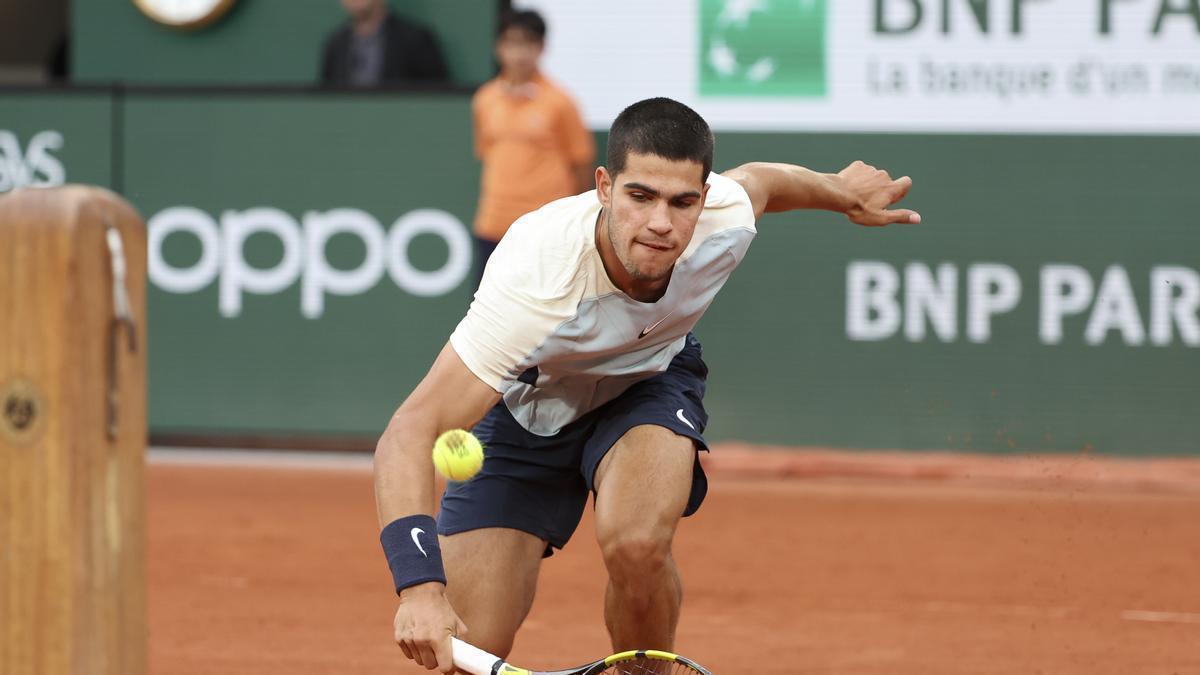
[596,153,708,285]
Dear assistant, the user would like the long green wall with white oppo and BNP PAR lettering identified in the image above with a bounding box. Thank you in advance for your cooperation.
[0,92,1200,454]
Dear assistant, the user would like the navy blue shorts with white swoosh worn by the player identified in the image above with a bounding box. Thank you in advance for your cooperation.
[438,334,708,556]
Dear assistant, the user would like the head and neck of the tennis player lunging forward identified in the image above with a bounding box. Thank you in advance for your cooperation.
[596,98,713,297]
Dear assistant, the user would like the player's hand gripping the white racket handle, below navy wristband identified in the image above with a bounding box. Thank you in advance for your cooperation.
[392,583,467,673]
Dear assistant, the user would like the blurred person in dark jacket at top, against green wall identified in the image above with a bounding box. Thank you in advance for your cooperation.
[320,0,446,88]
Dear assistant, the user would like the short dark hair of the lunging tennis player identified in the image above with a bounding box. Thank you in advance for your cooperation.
[607,97,714,181]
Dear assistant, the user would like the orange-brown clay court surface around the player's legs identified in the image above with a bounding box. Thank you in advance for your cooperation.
[148,446,1200,675]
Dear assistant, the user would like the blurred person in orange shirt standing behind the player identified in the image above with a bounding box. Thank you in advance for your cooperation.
[472,11,595,277]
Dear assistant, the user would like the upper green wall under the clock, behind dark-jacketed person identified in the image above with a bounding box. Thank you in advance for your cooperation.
[71,0,497,85]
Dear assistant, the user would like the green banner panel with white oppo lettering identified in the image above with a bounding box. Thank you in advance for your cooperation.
[125,95,479,436]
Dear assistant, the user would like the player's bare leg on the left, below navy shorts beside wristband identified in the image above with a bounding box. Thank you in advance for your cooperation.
[439,527,546,657]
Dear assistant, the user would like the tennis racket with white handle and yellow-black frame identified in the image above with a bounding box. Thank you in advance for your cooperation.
[451,638,713,675]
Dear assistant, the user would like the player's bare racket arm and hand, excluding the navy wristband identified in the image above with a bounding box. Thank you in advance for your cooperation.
[374,342,500,671]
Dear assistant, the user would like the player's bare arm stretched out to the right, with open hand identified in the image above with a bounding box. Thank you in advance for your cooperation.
[725,162,920,226]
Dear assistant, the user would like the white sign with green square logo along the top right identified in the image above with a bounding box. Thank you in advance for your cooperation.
[530,0,1200,133]
